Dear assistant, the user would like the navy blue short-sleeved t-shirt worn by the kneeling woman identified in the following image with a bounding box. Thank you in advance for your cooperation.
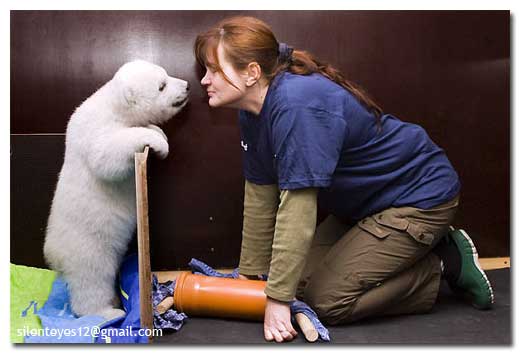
[239,72,460,220]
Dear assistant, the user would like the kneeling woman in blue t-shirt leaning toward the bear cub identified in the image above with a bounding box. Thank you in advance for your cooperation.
[195,17,493,342]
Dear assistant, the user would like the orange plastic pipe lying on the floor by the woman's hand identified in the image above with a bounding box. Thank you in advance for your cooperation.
[173,272,266,321]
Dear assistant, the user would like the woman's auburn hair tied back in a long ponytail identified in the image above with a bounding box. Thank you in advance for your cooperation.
[194,16,383,118]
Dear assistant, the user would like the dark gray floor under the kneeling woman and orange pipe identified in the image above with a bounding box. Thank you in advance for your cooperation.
[154,269,512,345]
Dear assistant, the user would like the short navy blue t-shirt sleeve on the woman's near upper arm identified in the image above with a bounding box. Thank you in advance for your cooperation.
[272,107,347,190]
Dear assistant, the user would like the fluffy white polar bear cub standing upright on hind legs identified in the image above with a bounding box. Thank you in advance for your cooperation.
[43,61,189,319]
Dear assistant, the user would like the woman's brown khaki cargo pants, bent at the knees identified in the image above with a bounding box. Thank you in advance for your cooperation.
[297,196,458,325]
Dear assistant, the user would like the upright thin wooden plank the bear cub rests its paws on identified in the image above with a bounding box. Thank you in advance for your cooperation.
[135,146,153,343]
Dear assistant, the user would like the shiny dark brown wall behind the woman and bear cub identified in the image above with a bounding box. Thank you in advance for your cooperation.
[11,11,510,269]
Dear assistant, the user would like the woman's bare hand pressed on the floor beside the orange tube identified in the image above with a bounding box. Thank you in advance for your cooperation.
[264,297,298,342]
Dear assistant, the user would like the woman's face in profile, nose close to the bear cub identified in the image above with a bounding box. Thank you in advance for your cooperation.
[200,45,247,109]
